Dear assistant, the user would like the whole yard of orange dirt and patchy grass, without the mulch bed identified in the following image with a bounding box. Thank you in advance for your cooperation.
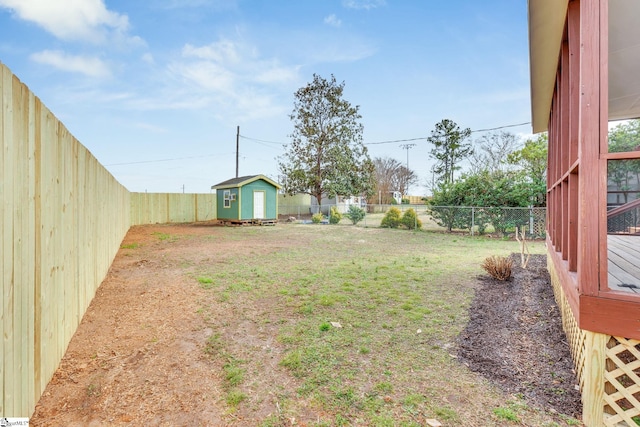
[31,224,579,427]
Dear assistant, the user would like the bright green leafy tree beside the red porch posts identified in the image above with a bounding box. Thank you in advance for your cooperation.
[507,133,549,206]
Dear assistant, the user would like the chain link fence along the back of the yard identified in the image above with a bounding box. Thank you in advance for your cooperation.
[278,204,547,238]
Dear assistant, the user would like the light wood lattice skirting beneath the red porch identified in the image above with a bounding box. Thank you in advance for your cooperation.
[548,259,640,427]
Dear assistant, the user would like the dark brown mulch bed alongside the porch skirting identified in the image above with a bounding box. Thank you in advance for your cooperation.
[458,254,582,418]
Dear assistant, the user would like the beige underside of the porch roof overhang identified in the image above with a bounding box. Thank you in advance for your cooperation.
[528,0,640,132]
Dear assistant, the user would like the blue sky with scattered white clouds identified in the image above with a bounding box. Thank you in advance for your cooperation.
[0,0,531,195]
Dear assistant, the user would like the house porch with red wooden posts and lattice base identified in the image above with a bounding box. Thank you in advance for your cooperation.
[528,0,640,427]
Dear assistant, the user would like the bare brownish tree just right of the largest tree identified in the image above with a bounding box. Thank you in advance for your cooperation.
[371,157,418,205]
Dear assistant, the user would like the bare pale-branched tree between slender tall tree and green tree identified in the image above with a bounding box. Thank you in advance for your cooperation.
[470,131,520,173]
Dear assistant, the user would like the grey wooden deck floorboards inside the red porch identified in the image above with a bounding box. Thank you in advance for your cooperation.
[607,235,640,294]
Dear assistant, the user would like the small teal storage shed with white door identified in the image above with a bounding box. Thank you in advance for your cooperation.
[211,175,281,225]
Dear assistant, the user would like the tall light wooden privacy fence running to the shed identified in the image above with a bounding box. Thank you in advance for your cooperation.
[0,63,215,418]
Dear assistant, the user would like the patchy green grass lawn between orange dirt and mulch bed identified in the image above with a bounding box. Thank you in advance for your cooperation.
[193,225,571,426]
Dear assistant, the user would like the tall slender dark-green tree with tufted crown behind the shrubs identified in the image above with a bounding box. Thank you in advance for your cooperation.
[427,119,473,184]
